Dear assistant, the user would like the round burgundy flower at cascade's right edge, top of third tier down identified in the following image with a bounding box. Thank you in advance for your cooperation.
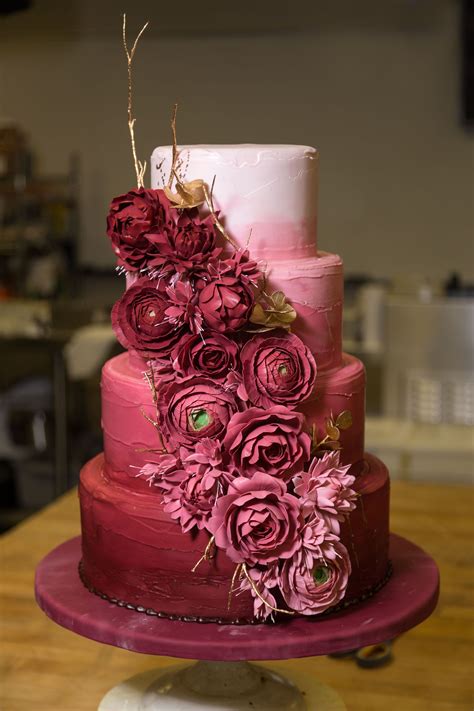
[241,332,316,408]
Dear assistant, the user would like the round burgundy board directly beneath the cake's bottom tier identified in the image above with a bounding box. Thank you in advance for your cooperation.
[35,534,439,662]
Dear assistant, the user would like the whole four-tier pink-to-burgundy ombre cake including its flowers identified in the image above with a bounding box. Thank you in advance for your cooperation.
[79,145,389,623]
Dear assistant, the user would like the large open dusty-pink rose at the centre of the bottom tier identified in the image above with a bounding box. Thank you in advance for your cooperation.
[208,472,302,565]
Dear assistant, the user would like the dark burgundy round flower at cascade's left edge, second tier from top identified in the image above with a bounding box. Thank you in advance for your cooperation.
[112,277,184,358]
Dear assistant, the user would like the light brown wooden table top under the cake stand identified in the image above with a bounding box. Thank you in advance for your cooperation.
[0,481,474,711]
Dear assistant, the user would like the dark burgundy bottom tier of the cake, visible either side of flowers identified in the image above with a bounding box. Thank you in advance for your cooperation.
[79,454,389,622]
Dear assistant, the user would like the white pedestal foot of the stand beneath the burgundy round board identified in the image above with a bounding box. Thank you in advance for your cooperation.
[98,661,346,711]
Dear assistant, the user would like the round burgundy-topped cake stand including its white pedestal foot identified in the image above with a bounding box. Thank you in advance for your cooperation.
[35,534,439,711]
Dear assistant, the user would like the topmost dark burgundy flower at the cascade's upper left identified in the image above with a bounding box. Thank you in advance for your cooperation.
[107,188,175,271]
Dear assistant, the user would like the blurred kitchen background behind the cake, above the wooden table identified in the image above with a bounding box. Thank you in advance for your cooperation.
[0,0,474,530]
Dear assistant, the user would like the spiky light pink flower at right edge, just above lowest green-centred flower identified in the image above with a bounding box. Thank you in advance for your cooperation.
[294,452,357,533]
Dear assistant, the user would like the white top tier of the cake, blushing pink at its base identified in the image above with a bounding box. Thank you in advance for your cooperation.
[151,143,319,261]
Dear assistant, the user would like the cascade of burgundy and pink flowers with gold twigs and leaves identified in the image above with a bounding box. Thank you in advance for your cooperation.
[107,13,356,620]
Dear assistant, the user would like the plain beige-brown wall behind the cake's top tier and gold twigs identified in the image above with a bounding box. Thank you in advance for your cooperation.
[0,2,474,278]
